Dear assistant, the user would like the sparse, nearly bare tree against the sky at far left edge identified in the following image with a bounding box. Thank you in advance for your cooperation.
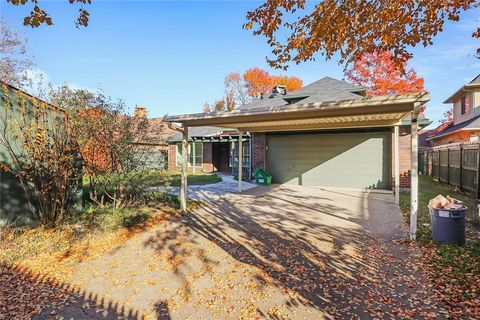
[0,18,33,87]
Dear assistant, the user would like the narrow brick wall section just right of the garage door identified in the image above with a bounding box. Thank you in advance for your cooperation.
[392,127,412,188]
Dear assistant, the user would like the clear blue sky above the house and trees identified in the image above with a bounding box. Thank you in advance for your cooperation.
[0,0,480,125]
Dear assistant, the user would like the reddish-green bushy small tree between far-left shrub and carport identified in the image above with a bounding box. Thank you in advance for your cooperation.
[50,86,154,208]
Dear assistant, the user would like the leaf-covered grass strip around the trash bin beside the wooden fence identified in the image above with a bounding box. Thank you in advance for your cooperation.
[400,176,480,319]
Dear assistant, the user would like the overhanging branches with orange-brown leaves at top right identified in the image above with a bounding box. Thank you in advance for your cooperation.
[244,0,480,69]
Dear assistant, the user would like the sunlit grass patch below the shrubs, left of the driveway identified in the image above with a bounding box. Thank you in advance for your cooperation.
[0,192,197,266]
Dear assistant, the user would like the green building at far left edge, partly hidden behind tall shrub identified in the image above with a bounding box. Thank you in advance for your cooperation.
[0,80,64,227]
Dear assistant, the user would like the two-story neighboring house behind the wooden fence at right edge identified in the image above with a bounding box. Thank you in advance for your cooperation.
[428,74,480,147]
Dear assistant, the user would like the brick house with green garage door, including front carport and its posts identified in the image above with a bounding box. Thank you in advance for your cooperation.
[165,77,429,239]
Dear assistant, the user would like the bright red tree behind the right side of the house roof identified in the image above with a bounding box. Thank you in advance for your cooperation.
[345,52,425,96]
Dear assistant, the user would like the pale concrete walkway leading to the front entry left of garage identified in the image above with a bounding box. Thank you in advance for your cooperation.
[152,173,257,202]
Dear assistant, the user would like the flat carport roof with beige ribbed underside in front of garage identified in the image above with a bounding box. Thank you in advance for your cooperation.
[165,93,429,132]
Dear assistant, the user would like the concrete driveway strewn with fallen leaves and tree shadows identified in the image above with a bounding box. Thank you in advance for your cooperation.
[38,186,442,319]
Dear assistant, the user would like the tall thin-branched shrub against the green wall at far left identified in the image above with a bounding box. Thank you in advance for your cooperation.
[0,85,81,225]
